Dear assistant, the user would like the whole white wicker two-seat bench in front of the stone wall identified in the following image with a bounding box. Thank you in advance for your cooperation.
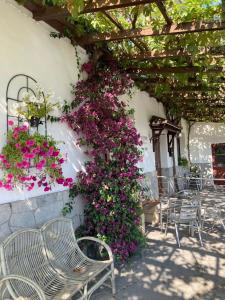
[0,218,115,300]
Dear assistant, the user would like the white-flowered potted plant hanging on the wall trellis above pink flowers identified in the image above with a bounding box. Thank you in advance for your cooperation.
[17,87,59,128]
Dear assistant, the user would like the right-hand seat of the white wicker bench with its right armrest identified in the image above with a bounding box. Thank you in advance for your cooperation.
[41,218,116,298]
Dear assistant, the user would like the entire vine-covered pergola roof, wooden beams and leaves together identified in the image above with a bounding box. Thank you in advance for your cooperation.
[21,0,225,121]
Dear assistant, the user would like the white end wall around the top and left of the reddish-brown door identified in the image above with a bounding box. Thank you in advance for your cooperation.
[190,123,225,164]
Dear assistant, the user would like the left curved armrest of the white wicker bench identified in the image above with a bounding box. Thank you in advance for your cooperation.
[0,274,46,300]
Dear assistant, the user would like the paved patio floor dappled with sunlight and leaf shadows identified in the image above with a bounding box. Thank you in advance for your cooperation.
[91,189,225,300]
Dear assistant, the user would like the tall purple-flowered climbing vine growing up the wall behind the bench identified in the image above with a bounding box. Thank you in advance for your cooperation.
[63,63,143,260]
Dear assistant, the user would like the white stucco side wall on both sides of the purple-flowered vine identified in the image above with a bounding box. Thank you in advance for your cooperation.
[0,0,172,204]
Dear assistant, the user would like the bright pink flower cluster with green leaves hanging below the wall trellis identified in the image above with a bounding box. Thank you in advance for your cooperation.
[0,121,73,192]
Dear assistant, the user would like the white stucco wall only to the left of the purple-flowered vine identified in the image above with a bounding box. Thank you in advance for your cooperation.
[0,0,87,203]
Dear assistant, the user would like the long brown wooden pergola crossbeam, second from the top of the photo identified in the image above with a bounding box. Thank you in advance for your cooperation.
[80,21,225,45]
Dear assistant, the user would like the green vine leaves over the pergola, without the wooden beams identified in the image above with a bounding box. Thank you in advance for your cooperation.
[27,0,225,119]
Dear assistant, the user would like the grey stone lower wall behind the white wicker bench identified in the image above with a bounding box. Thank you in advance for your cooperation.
[0,191,84,241]
